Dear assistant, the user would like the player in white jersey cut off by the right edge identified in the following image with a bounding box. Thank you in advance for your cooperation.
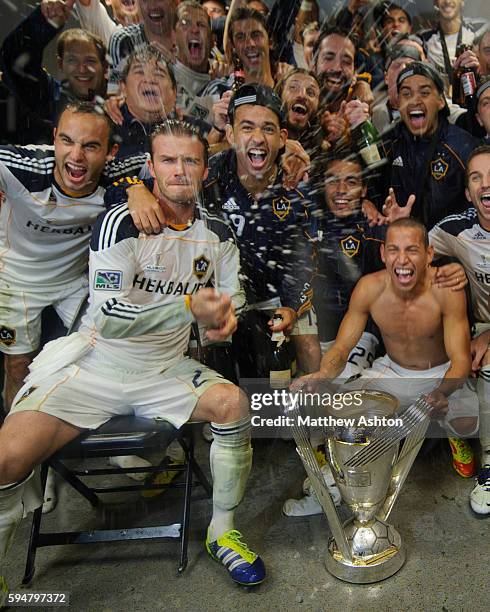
[429,145,490,516]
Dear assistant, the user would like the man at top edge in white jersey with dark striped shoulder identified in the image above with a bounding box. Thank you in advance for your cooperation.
[109,0,177,94]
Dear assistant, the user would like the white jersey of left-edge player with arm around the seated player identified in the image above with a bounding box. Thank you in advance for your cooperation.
[0,146,146,289]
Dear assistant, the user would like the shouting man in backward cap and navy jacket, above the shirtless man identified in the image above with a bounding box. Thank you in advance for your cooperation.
[383,62,477,229]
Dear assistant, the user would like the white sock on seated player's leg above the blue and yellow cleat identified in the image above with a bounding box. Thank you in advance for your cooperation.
[209,416,252,541]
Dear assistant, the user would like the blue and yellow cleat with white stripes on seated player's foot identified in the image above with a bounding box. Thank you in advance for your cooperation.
[206,529,265,586]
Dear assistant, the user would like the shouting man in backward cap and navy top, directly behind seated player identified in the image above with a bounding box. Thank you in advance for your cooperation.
[205,83,320,376]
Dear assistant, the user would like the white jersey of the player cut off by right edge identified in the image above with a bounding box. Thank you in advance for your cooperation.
[429,207,490,323]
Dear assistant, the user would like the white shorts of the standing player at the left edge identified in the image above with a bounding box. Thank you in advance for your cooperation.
[0,278,88,355]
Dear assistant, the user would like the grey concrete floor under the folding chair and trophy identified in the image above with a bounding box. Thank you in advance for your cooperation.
[1,440,490,612]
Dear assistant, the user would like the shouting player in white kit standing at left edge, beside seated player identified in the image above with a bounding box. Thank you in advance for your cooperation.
[0,102,145,412]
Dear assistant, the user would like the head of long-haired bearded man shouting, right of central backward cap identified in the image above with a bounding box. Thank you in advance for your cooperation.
[275,68,323,159]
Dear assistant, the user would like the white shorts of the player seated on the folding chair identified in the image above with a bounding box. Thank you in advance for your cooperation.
[7,351,232,429]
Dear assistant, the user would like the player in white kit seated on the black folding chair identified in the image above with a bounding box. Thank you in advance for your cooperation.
[0,120,265,585]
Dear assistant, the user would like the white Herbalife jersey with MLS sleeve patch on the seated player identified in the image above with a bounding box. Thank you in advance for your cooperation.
[80,204,245,373]
